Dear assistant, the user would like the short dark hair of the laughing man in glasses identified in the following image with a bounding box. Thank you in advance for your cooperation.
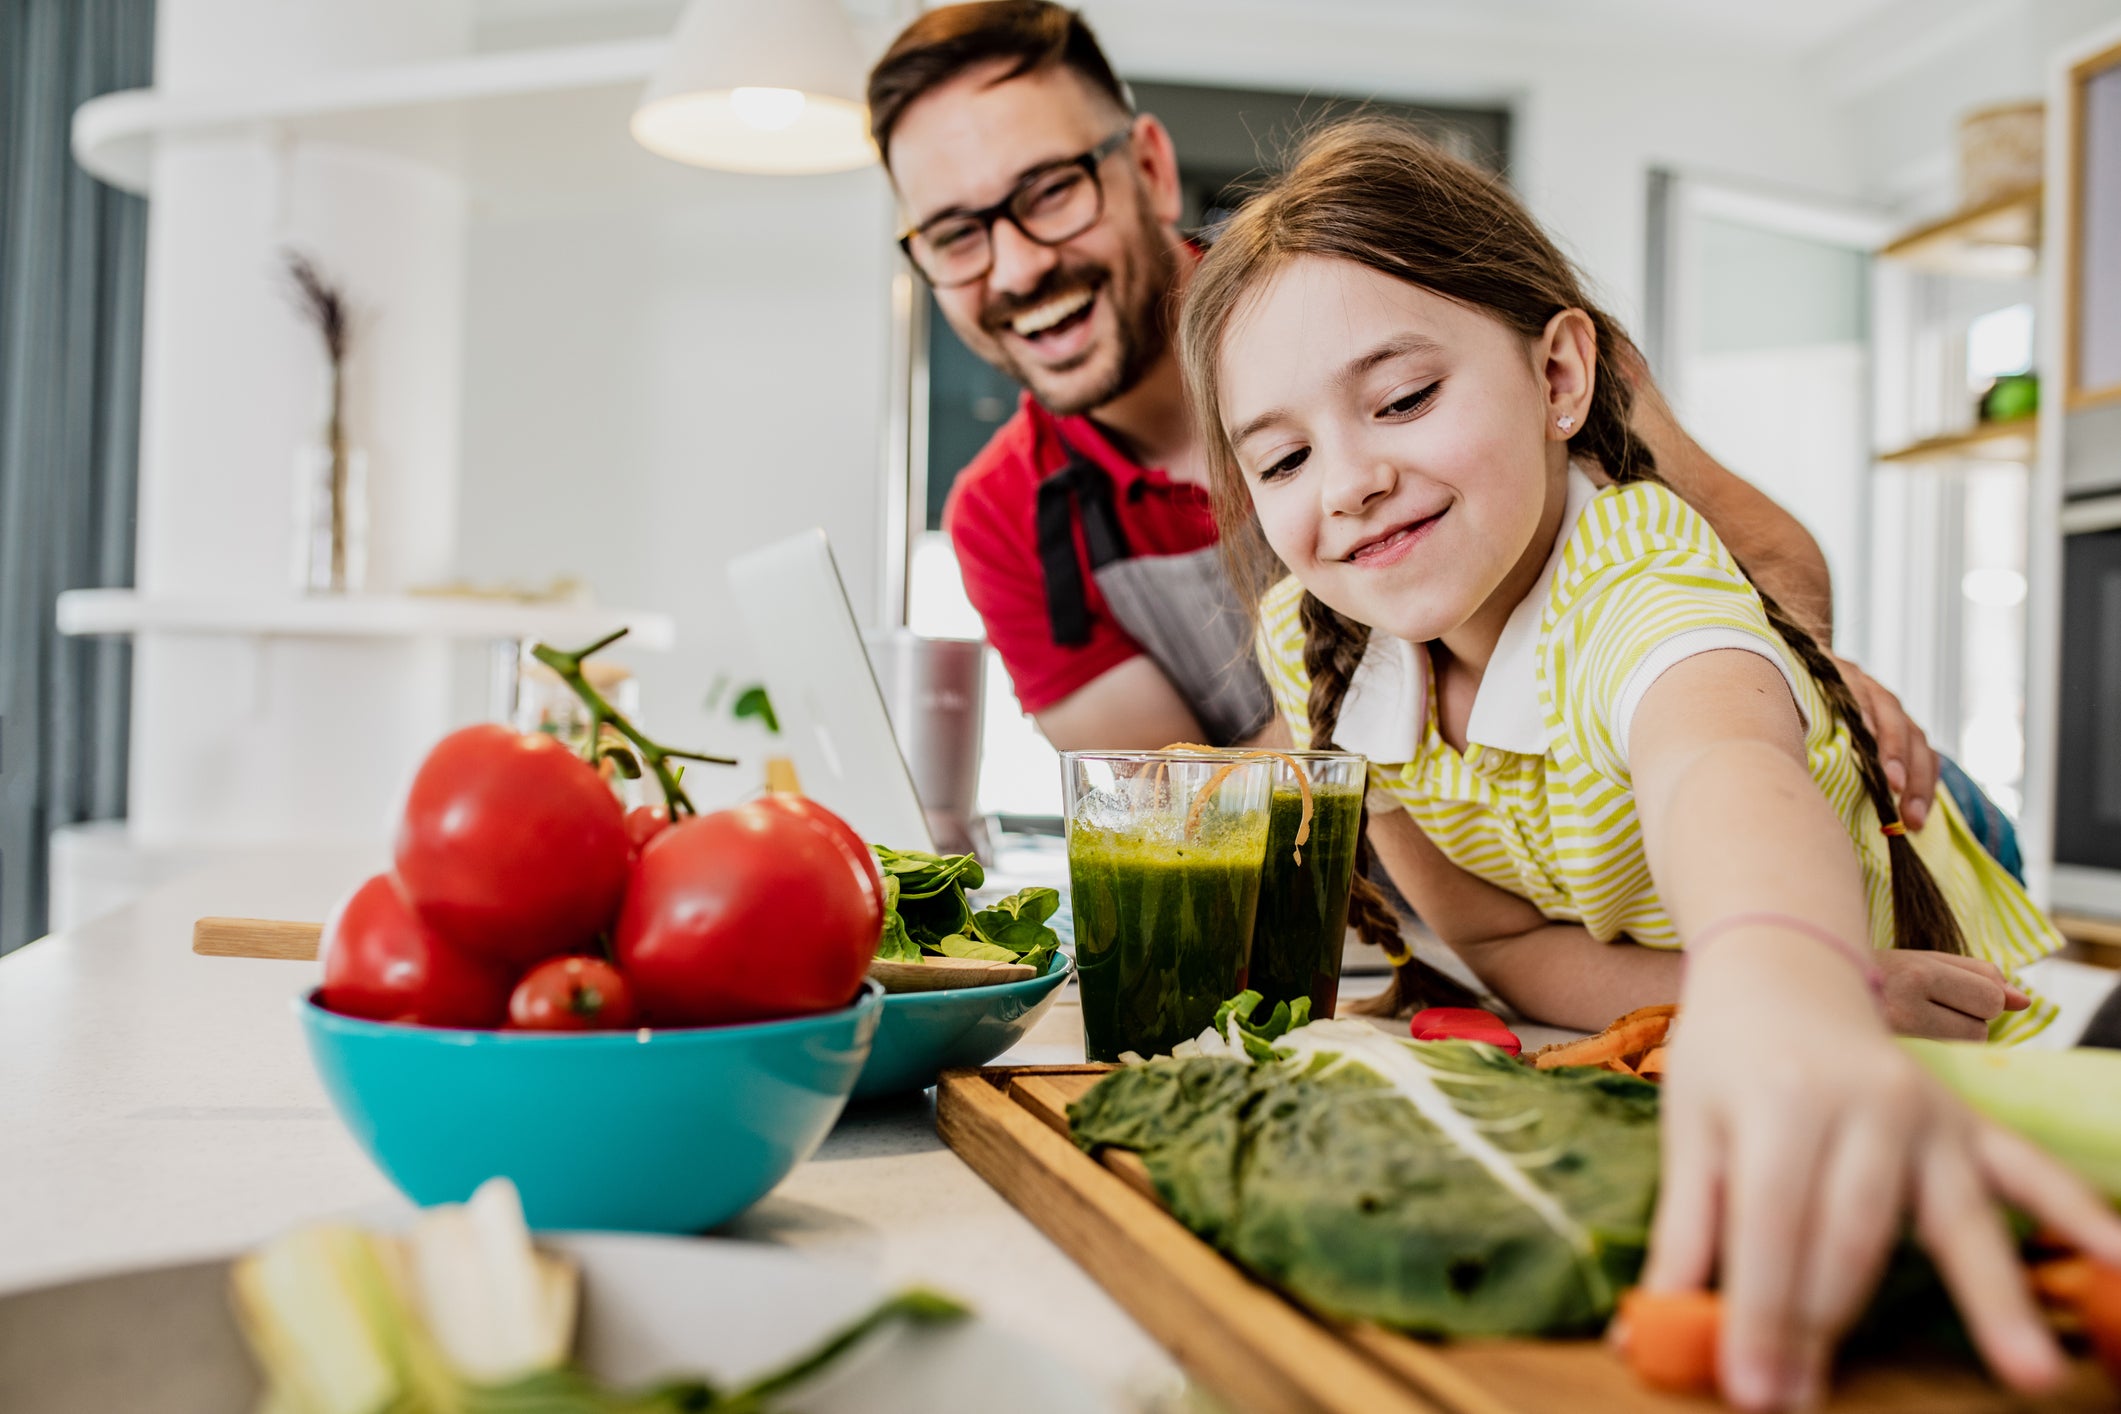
[870,0,1133,165]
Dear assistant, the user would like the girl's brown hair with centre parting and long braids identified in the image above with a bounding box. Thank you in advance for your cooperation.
[1179,117,1966,1004]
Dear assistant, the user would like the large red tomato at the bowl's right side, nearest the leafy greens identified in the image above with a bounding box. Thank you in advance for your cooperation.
[617,795,884,1026]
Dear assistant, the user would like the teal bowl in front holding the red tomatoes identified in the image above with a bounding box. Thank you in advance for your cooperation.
[295,982,884,1232]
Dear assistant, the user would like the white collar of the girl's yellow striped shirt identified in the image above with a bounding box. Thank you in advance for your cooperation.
[1334,462,1597,761]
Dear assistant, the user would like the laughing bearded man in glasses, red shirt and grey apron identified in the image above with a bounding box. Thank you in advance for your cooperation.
[870,0,1936,827]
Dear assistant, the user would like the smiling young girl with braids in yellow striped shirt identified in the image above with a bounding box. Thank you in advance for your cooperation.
[1181,121,2121,1408]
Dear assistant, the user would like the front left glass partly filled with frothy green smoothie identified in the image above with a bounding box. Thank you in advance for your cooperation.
[1061,750,1275,1060]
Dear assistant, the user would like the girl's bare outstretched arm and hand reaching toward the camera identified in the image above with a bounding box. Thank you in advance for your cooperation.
[1627,651,2121,1410]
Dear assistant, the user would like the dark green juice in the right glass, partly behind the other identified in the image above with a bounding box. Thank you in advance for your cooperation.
[1247,784,1362,1018]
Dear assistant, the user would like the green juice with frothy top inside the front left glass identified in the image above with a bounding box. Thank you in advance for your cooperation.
[1067,831,1262,1060]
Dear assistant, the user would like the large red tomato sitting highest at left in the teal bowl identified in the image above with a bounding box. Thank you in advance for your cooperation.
[397,723,630,967]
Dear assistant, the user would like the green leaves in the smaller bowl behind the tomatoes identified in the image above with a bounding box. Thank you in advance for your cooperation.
[870,844,1061,973]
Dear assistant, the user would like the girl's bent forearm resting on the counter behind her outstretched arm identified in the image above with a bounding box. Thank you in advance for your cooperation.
[1370,810,1680,1030]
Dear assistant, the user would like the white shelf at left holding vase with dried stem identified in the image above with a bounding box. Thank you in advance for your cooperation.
[57,589,677,651]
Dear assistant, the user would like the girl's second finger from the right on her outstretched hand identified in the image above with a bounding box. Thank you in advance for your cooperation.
[1913,1134,2064,1391]
